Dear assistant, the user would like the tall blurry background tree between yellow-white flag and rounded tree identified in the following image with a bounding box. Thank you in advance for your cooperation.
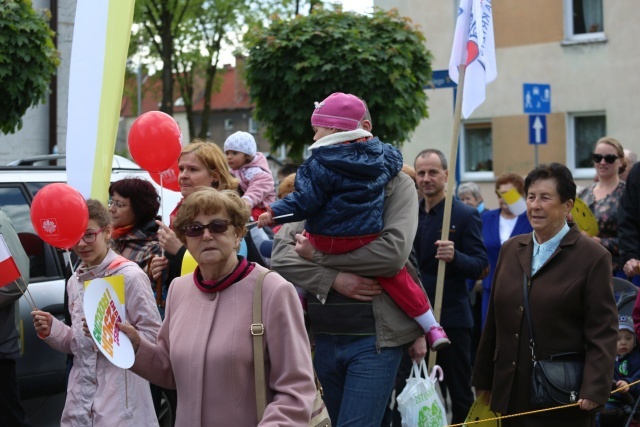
[129,0,300,139]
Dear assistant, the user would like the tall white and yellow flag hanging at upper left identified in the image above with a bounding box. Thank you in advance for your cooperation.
[67,0,135,203]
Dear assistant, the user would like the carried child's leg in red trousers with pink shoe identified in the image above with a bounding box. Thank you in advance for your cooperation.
[376,267,451,351]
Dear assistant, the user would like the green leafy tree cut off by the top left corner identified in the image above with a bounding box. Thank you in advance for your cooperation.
[0,0,60,134]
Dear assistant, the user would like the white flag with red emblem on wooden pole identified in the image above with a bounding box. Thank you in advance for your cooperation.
[449,0,498,119]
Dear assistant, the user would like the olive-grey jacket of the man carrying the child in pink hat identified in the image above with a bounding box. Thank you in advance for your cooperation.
[271,173,424,347]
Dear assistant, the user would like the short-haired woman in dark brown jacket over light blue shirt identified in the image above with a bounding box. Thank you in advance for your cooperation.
[473,163,618,427]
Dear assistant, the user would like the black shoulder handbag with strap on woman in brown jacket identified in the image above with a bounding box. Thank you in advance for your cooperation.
[523,274,584,409]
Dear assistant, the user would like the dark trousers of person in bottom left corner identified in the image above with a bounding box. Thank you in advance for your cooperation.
[0,359,31,427]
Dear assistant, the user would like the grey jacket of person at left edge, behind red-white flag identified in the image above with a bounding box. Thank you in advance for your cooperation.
[0,210,29,359]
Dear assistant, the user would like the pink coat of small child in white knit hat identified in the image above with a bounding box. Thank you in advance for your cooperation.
[231,152,276,208]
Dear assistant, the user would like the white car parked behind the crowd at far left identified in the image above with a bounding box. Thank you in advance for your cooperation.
[0,155,181,425]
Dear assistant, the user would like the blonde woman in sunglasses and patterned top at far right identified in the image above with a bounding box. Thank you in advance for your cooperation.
[578,136,627,278]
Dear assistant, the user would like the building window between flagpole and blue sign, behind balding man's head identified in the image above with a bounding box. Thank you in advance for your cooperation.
[460,122,493,180]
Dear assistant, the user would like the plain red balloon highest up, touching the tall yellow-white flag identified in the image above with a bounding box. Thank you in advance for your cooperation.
[129,111,182,173]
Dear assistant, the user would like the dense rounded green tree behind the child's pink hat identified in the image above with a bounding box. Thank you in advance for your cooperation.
[245,8,431,159]
